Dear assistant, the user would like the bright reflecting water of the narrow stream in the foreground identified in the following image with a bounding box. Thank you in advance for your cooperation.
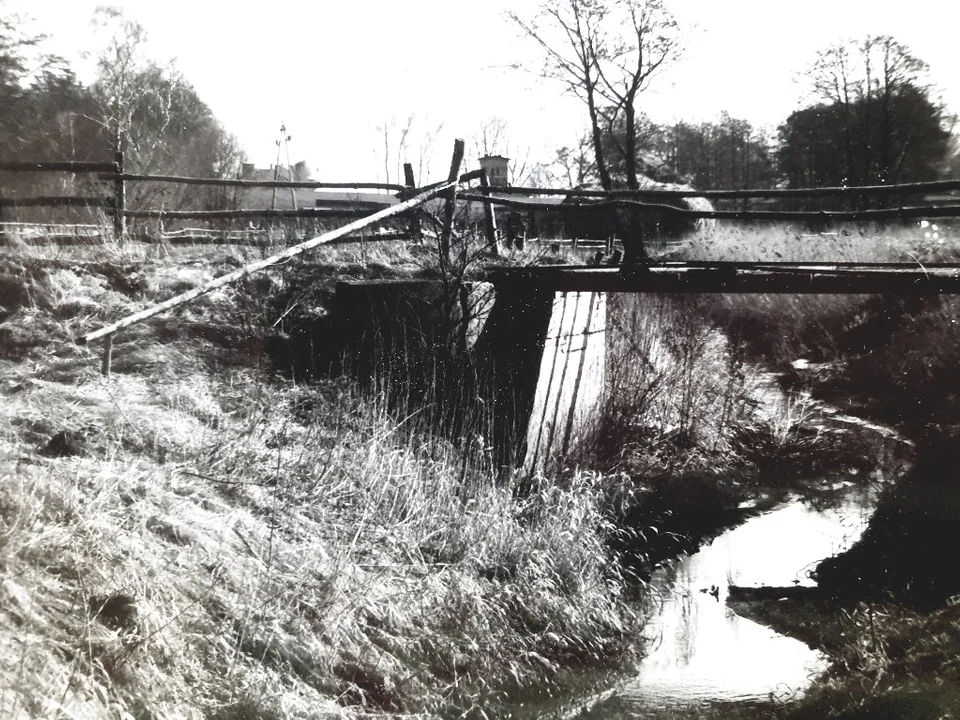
[584,483,878,720]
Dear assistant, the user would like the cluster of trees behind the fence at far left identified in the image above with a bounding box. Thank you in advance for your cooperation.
[0,0,244,214]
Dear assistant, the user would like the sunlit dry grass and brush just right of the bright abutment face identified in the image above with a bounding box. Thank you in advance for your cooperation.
[587,294,822,482]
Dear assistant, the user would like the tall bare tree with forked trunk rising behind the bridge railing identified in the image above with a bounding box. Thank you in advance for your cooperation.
[508,0,682,190]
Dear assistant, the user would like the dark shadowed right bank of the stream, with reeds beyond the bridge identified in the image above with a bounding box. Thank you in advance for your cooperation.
[672,223,960,718]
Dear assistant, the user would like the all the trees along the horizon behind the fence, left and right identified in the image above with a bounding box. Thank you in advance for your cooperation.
[0,0,960,218]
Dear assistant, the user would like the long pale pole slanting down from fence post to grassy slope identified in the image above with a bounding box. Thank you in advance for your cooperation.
[77,179,457,345]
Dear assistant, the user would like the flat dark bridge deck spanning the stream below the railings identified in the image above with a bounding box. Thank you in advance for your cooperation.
[490,262,960,295]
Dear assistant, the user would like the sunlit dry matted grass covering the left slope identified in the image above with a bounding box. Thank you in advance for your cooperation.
[0,243,640,718]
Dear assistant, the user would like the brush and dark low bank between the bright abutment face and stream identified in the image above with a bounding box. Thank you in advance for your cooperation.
[571,294,889,573]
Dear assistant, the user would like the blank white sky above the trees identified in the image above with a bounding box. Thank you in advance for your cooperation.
[8,0,960,182]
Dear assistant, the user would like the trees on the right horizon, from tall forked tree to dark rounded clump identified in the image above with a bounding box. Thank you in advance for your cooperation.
[509,0,960,190]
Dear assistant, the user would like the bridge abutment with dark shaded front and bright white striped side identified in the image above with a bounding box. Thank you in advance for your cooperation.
[337,281,606,474]
